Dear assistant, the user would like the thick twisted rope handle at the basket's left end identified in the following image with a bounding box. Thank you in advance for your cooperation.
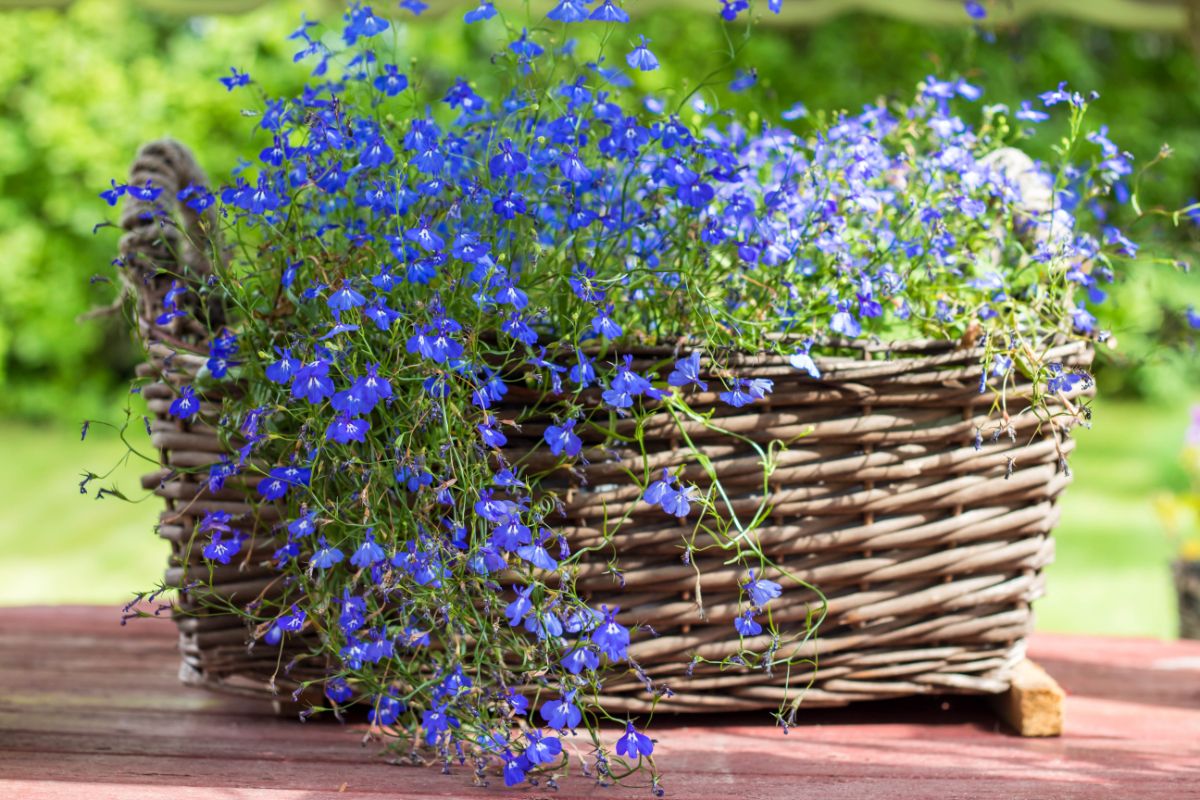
[120,139,224,348]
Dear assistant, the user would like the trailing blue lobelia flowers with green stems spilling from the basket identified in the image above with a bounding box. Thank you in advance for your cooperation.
[103,0,1136,787]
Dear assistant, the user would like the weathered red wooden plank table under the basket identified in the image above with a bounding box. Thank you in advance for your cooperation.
[0,607,1200,800]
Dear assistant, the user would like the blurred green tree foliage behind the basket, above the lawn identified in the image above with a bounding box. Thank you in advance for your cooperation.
[0,0,1200,419]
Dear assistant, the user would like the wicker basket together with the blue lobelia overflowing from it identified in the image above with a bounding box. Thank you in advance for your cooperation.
[96,0,1161,789]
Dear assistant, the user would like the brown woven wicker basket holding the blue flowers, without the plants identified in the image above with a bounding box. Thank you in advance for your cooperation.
[121,142,1091,711]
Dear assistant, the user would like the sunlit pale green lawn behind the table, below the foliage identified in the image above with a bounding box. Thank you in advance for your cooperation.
[0,403,1188,637]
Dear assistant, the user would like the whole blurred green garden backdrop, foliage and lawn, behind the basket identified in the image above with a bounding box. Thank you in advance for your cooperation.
[0,0,1200,637]
